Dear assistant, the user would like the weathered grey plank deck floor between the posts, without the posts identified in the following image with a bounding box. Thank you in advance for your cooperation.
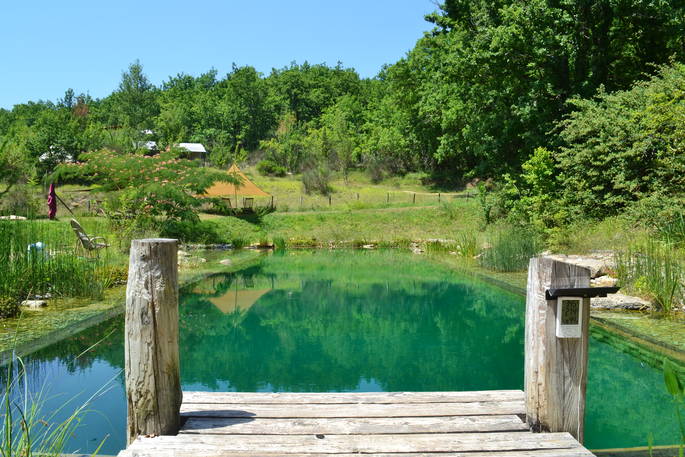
[119,391,593,457]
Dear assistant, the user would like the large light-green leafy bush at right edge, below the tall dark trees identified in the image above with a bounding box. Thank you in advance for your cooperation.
[558,64,685,217]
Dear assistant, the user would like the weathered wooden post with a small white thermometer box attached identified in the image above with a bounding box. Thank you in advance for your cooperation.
[524,257,590,443]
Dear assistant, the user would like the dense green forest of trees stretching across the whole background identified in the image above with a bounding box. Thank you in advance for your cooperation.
[0,0,685,228]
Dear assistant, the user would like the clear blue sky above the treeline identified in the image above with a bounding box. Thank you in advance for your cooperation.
[0,0,436,108]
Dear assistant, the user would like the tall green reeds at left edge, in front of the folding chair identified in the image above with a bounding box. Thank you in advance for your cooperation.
[0,220,108,317]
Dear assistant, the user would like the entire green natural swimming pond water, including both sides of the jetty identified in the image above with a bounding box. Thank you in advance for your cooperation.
[8,251,677,454]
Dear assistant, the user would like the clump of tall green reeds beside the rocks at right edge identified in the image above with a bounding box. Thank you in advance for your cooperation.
[615,240,683,312]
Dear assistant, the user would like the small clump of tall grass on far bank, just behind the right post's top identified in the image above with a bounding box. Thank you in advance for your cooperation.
[480,227,542,272]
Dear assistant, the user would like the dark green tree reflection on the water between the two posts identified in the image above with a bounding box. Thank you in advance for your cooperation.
[181,268,523,391]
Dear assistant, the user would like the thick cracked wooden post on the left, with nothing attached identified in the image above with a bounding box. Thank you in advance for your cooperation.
[125,238,182,444]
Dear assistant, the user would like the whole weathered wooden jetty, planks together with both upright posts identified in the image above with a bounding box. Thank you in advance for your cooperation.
[119,239,593,457]
